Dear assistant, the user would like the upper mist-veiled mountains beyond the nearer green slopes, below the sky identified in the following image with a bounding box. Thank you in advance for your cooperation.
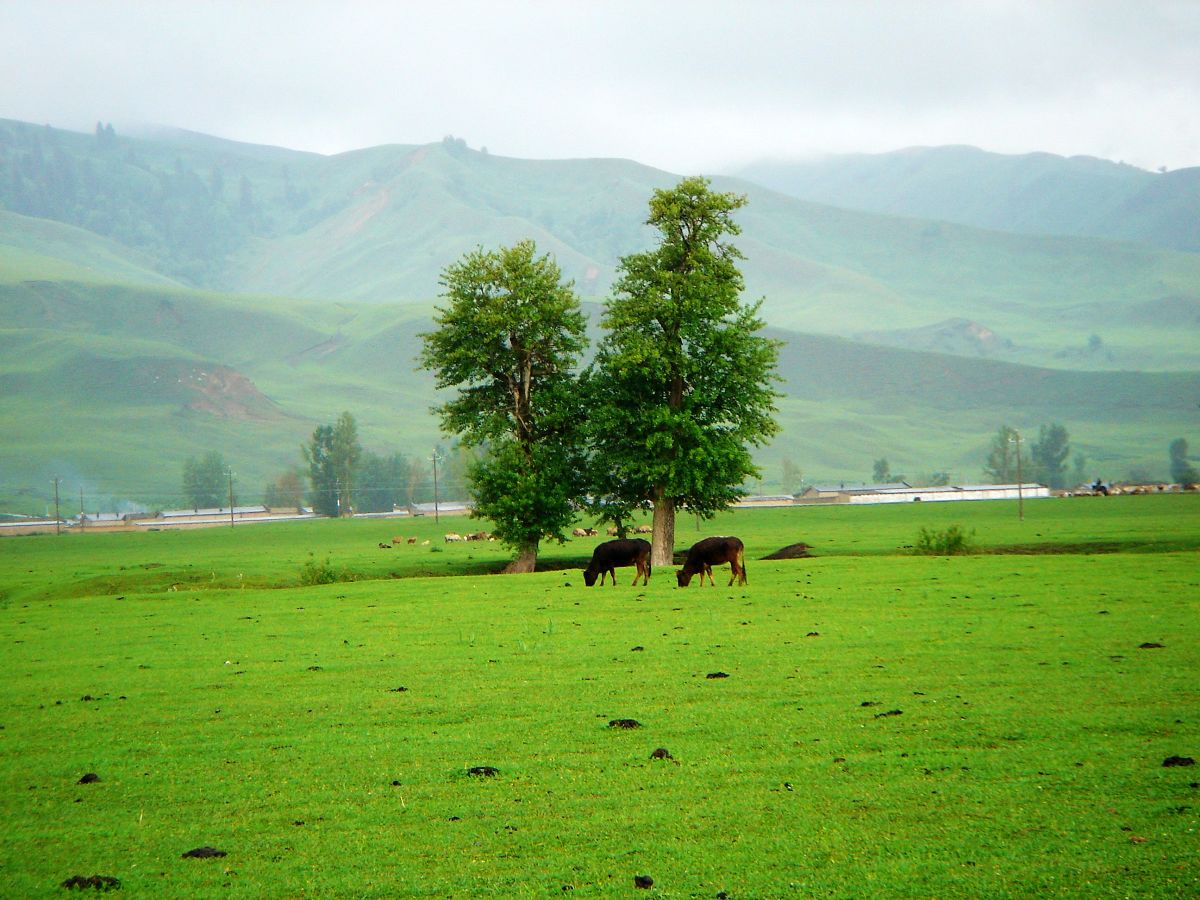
[0,121,1200,370]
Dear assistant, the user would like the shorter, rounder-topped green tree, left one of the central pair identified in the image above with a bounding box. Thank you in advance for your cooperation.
[421,241,587,571]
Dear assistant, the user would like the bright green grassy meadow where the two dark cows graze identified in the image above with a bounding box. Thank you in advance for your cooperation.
[0,496,1200,898]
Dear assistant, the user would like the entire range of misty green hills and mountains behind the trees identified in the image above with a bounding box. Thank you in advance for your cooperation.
[0,120,1200,500]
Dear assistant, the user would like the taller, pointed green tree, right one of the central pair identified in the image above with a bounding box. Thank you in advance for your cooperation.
[589,178,778,565]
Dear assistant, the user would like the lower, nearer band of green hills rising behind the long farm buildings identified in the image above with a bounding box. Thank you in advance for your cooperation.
[0,281,1200,511]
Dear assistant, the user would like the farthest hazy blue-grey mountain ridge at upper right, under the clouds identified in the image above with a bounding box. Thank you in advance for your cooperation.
[736,146,1200,252]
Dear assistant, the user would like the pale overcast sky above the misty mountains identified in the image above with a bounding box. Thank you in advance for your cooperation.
[0,0,1200,174]
